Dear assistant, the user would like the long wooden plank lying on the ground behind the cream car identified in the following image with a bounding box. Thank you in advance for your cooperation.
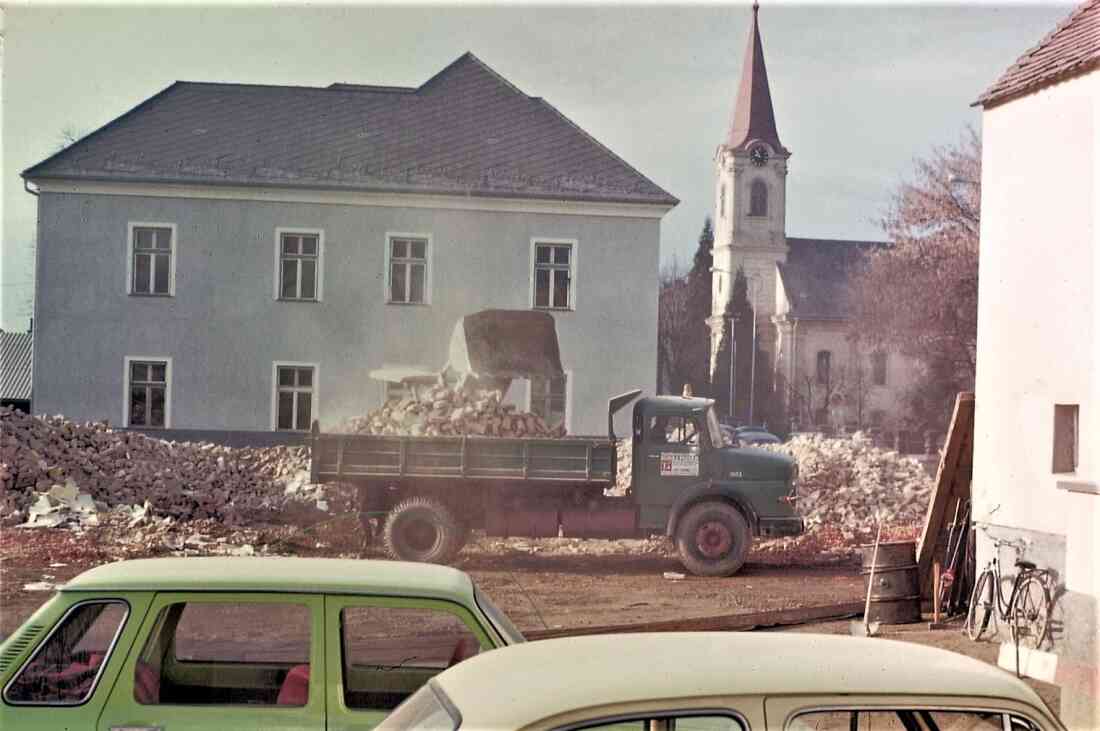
[524,601,864,640]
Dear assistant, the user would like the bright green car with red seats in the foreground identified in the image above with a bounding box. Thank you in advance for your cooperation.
[0,558,524,731]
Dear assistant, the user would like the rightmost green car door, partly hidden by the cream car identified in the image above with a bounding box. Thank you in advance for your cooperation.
[323,596,495,731]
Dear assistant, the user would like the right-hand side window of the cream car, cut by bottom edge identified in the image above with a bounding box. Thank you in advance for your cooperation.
[787,708,1004,731]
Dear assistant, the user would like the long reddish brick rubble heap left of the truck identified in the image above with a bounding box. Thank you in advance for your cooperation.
[0,408,329,527]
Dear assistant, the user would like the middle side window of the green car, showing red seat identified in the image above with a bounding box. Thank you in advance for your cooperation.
[134,601,312,706]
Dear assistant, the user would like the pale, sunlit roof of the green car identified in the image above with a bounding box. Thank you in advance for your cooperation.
[62,556,473,600]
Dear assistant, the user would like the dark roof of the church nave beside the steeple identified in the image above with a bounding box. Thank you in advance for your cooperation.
[778,239,888,320]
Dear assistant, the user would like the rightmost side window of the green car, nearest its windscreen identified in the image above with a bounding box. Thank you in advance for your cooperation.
[340,606,488,710]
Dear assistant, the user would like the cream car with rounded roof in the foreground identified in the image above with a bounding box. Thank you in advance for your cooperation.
[378,632,1064,731]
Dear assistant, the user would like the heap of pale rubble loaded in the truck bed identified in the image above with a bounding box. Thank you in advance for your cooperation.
[342,385,565,439]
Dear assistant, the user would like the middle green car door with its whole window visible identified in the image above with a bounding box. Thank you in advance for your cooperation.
[98,591,326,731]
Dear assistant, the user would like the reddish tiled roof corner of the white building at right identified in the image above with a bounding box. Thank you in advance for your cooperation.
[974,0,1100,109]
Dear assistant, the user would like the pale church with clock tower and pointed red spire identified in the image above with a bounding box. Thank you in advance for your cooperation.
[707,5,915,430]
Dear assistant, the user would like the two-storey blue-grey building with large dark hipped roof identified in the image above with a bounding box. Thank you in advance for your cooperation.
[23,53,678,433]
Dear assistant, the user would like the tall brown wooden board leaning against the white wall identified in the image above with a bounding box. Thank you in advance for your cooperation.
[916,391,974,599]
